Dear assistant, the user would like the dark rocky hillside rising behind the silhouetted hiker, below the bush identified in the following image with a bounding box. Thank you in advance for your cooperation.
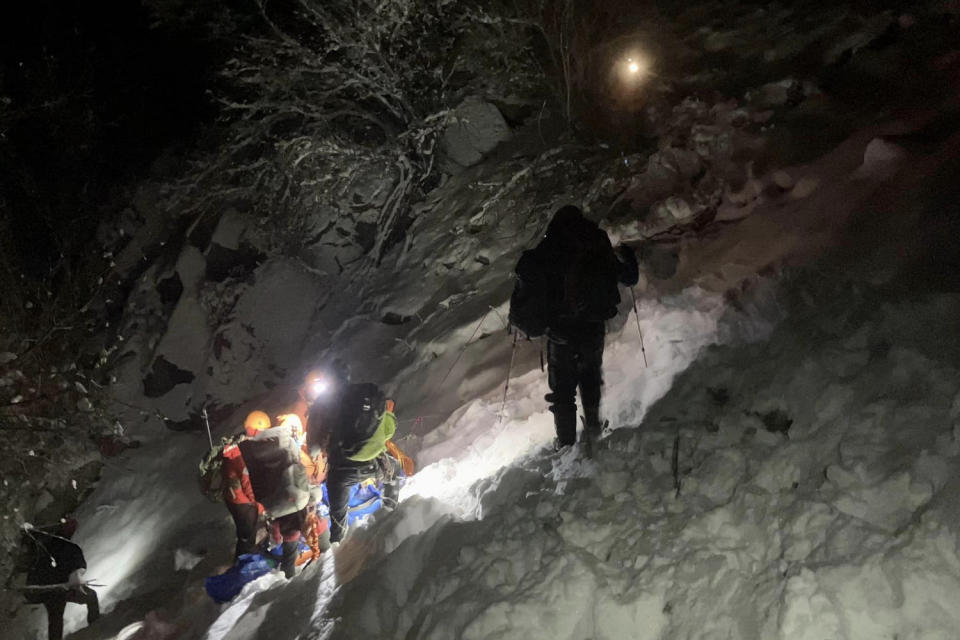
[103,4,957,444]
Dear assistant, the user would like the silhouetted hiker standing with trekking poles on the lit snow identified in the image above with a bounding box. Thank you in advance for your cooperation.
[510,205,639,453]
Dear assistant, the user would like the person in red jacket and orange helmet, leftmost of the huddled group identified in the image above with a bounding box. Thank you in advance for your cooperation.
[222,411,270,557]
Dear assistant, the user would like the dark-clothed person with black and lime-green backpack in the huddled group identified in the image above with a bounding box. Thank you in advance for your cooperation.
[308,360,400,543]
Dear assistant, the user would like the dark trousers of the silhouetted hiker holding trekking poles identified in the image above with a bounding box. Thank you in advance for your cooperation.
[545,324,604,446]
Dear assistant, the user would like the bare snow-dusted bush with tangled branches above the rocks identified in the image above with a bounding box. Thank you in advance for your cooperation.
[165,0,544,265]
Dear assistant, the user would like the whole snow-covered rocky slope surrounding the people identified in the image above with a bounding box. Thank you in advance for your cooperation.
[18,2,960,640]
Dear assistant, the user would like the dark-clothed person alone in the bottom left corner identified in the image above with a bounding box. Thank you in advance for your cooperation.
[24,518,100,640]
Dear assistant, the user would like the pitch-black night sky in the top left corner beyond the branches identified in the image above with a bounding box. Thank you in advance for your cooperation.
[0,0,213,275]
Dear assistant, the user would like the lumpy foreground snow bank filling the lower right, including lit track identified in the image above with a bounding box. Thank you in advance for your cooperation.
[189,278,960,640]
